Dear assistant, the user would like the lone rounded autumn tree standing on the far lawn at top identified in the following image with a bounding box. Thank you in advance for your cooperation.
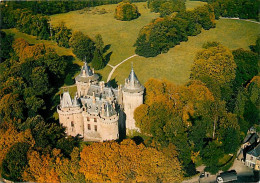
[115,1,140,21]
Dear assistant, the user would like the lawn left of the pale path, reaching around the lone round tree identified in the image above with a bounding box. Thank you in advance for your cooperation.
[51,2,159,80]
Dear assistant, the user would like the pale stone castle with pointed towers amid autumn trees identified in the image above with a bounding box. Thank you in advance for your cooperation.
[57,62,144,142]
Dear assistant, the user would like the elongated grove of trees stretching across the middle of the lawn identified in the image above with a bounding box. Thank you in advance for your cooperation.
[134,5,216,57]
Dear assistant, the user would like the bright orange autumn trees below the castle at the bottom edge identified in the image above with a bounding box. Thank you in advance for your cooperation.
[80,139,182,182]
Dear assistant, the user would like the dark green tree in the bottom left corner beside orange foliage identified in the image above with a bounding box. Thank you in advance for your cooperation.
[2,142,30,181]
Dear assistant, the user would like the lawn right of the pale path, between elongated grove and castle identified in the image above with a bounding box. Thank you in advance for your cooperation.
[112,20,260,84]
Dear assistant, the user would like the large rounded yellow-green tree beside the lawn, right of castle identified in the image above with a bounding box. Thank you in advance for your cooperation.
[191,45,237,98]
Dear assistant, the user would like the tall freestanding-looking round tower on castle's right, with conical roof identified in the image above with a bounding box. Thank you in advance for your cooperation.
[122,66,144,131]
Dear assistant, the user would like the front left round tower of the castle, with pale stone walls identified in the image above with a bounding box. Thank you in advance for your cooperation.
[57,92,83,136]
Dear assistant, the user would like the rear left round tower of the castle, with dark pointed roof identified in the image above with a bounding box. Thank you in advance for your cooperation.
[75,62,99,97]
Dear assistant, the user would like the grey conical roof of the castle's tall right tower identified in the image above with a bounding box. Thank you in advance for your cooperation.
[123,66,144,92]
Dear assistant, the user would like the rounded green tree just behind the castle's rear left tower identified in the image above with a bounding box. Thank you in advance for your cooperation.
[69,31,95,62]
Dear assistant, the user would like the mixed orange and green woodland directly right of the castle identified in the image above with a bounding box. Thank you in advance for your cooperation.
[135,42,260,175]
